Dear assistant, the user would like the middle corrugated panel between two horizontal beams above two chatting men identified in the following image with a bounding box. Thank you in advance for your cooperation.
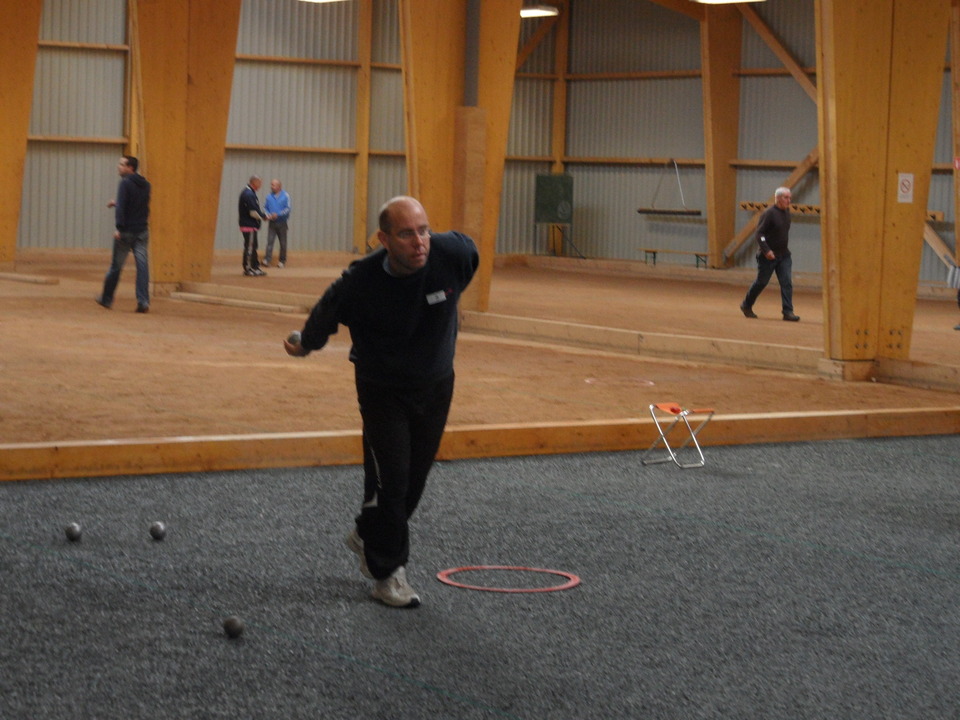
[227,62,356,148]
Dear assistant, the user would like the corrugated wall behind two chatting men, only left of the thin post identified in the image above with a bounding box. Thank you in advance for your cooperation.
[215,0,358,253]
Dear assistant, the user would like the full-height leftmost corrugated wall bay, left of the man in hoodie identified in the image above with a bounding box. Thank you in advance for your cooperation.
[17,0,127,248]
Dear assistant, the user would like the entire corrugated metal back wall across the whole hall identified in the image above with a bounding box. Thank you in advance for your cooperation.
[18,0,956,282]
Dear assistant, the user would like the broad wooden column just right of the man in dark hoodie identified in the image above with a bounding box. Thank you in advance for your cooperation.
[134,0,240,294]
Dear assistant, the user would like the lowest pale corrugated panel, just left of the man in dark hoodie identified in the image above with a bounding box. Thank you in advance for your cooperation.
[17,142,123,250]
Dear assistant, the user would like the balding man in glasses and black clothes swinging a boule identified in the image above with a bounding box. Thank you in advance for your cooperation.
[284,197,479,607]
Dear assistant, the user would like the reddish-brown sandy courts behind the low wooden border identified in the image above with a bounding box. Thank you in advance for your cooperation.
[0,251,960,443]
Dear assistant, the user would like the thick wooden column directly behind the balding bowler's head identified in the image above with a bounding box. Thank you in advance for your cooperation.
[400,0,520,310]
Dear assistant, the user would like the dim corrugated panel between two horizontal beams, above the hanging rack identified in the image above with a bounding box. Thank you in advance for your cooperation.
[567,78,703,158]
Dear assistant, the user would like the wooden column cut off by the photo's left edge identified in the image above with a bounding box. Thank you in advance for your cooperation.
[0,0,43,269]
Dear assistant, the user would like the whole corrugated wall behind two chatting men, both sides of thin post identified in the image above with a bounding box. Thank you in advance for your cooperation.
[216,0,406,255]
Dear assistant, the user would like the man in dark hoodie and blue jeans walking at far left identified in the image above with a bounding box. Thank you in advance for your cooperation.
[96,155,150,313]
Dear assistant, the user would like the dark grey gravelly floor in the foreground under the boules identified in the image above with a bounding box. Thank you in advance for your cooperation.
[0,436,960,720]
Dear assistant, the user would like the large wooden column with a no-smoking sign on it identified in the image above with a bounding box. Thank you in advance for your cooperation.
[816,0,949,379]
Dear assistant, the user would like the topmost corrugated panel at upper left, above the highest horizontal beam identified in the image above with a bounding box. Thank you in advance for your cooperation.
[39,0,127,45]
